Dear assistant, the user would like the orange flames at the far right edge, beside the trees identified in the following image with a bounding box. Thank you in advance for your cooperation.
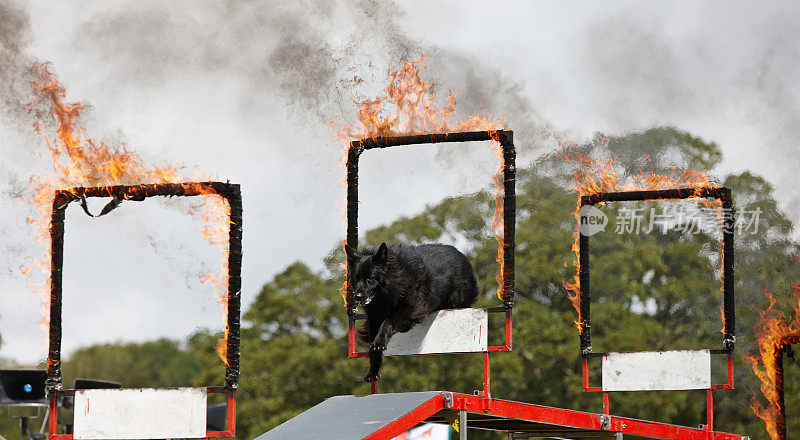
[744,282,800,440]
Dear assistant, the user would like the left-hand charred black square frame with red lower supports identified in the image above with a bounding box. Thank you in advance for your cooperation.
[45,182,242,440]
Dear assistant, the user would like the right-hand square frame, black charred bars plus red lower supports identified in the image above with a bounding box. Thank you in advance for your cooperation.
[578,187,736,430]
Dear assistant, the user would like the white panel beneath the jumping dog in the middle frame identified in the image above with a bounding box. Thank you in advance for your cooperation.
[383,309,489,356]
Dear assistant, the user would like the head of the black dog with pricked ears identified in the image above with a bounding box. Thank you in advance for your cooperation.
[346,243,389,305]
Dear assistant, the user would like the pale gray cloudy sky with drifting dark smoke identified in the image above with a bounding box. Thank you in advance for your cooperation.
[0,0,800,362]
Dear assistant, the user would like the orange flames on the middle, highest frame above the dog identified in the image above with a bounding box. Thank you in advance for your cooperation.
[328,53,507,299]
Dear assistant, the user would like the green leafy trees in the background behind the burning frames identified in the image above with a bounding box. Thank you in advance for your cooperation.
[3,127,800,440]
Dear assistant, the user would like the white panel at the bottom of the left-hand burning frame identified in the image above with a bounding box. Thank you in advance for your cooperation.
[73,388,207,440]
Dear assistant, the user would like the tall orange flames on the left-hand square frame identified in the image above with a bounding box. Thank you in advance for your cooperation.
[25,64,230,360]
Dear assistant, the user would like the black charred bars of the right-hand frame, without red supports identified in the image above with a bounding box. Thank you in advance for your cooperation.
[578,187,736,357]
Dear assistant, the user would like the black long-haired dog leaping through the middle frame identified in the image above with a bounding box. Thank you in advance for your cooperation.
[347,243,478,382]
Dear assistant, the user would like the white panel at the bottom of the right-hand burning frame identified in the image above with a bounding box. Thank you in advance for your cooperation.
[602,350,711,391]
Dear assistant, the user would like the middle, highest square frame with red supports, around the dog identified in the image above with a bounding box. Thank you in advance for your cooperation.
[345,130,517,360]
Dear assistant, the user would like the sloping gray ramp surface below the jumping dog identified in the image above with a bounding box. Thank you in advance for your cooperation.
[255,391,441,440]
